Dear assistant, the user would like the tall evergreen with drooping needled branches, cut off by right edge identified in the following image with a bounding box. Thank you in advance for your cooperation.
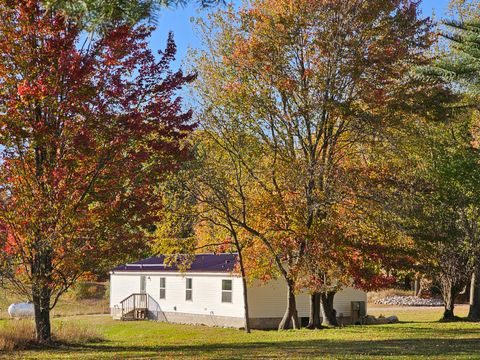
[423,16,480,321]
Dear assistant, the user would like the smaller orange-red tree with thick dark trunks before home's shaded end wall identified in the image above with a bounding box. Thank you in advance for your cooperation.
[297,150,414,328]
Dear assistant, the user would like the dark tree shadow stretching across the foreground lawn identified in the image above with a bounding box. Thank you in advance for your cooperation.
[20,331,480,358]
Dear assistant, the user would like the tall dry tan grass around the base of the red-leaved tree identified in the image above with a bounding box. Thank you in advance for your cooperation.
[0,320,103,351]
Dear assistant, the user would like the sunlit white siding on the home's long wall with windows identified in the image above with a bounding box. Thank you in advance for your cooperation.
[110,272,244,317]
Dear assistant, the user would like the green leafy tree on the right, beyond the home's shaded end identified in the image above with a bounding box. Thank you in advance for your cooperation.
[381,102,480,319]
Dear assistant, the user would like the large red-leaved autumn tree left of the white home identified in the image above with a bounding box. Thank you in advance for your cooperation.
[0,0,193,342]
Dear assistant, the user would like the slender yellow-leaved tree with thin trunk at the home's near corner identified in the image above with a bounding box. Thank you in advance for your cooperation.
[156,130,274,332]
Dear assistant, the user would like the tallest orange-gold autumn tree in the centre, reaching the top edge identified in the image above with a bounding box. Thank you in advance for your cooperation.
[195,0,440,328]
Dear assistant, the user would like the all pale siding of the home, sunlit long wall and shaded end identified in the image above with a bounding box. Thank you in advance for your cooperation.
[110,272,367,318]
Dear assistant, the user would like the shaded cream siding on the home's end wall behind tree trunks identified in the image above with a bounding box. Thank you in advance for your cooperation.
[248,280,367,318]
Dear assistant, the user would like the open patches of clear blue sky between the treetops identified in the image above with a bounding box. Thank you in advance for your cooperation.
[150,0,454,66]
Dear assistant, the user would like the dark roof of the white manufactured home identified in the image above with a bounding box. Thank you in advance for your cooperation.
[112,254,237,273]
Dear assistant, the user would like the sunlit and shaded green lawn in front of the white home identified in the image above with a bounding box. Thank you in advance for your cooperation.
[0,307,480,359]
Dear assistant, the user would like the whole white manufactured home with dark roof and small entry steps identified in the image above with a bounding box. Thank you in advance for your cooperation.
[110,254,367,329]
